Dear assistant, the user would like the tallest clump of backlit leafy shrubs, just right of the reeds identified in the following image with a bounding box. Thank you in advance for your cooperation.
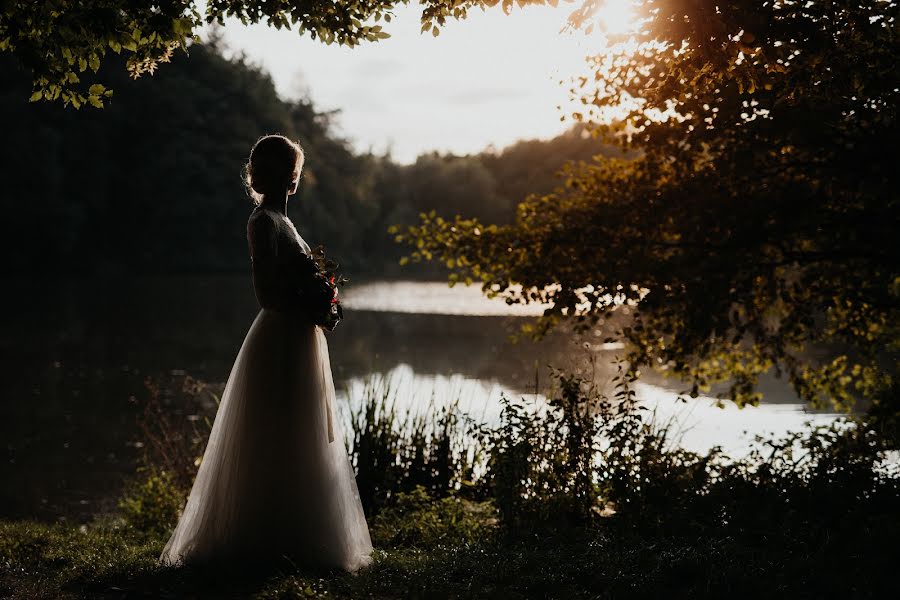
[477,365,720,531]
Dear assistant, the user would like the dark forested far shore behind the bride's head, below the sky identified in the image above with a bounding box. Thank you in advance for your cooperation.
[0,42,620,277]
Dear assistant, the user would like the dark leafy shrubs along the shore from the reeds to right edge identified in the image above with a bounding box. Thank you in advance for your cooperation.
[478,365,900,535]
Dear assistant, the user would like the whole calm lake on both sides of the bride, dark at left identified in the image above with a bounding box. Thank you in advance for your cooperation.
[0,275,834,520]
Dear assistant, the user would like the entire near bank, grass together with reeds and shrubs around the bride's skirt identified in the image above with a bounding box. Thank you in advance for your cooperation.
[8,377,900,600]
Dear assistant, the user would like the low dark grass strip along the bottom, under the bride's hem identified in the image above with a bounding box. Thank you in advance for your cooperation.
[0,496,900,599]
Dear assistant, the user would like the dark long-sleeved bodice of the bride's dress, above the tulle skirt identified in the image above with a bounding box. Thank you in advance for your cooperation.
[247,208,310,311]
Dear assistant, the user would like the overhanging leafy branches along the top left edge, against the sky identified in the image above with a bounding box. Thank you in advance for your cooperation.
[0,0,555,108]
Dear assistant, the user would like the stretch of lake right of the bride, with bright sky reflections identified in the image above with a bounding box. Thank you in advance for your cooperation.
[332,282,834,455]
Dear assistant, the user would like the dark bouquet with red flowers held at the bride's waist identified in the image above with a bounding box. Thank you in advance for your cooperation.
[297,246,347,331]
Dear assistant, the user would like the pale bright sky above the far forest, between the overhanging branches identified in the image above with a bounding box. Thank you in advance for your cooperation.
[211,0,615,163]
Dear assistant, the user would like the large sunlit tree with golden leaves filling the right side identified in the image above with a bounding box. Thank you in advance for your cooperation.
[398,0,900,407]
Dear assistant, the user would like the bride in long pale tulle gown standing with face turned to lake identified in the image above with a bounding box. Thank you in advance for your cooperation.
[160,135,372,571]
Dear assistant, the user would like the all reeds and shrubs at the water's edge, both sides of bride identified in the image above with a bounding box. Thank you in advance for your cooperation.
[132,364,900,545]
